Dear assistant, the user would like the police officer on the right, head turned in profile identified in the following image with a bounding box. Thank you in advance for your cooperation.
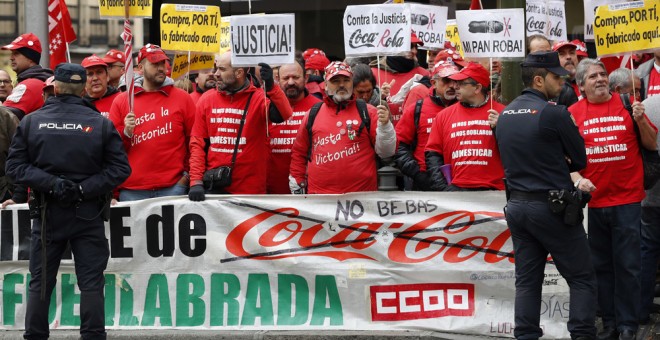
[496,52,596,339]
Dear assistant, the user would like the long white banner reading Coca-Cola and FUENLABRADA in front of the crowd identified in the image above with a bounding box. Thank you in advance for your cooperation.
[0,192,569,339]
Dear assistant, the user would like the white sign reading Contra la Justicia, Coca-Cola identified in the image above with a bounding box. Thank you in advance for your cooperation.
[344,4,411,57]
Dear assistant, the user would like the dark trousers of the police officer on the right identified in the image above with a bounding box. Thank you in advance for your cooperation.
[506,199,597,339]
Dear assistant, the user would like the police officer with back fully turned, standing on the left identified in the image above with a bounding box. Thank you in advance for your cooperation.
[6,63,131,339]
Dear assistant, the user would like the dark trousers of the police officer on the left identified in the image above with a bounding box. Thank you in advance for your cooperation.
[23,202,110,340]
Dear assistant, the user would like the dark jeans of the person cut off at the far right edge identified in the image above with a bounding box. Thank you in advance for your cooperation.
[639,207,660,320]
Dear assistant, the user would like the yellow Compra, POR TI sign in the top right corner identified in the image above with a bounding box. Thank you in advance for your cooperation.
[594,0,660,56]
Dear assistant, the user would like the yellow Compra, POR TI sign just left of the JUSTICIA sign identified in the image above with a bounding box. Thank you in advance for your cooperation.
[160,4,220,53]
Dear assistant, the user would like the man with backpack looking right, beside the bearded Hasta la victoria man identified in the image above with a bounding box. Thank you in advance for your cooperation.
[394,62,458,191]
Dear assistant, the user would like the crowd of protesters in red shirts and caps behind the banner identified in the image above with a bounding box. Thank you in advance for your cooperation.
[0,27,660,339]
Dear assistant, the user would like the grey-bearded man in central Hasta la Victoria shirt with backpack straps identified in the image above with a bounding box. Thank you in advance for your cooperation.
[289,61,396,194]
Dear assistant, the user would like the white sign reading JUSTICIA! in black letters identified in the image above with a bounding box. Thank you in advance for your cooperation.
[229,14,296,67]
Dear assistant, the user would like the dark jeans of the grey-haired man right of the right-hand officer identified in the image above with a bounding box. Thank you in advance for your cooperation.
[589,203,642,331]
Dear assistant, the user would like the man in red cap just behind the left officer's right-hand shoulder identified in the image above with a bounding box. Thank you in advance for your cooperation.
[80,54,119,118]
